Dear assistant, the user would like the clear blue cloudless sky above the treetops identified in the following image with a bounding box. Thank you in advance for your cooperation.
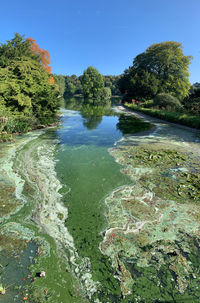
[0,0,200,83]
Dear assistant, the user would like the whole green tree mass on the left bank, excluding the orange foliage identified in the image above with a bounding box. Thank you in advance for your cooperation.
[0,34,59,140]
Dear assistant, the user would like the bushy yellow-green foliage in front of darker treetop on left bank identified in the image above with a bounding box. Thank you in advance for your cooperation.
[0,57,58,120]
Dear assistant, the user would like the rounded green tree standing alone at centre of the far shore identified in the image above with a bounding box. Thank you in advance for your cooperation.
[82,66,104,104]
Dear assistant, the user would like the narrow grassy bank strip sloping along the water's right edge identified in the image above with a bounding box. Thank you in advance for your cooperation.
[124,103,200,129]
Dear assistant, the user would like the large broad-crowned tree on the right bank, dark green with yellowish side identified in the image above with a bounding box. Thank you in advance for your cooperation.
[119,41,191,101]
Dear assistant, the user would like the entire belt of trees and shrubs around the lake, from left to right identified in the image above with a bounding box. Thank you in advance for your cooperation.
[0,34,200,141]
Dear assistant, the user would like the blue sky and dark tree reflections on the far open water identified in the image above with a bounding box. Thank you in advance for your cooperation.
[58,98,151,147]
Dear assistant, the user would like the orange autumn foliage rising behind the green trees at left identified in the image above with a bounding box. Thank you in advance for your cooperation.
[26,38,54,84]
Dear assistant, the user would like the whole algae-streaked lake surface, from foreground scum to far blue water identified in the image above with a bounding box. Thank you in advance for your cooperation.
[0,101,200,303]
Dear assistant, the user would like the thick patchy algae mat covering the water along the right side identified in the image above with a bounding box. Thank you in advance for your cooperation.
[100,130,200,302]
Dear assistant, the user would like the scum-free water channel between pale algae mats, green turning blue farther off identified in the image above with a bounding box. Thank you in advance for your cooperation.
[56,112,134,302]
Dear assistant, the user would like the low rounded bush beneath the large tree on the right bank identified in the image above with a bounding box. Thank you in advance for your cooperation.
[154,94,182,111]
